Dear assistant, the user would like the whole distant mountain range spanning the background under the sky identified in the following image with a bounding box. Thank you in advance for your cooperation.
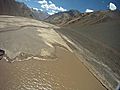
[0,0,120,26]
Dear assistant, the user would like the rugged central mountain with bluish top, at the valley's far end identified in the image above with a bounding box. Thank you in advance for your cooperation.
[44,10,82,25]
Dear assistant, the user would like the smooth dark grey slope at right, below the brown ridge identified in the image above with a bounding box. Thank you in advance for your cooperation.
[56,22,120,89]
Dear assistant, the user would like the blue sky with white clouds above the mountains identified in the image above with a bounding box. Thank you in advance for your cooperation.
[16,0,120,14]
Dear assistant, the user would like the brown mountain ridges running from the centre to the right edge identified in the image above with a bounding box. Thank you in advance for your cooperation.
[45,10,120,26]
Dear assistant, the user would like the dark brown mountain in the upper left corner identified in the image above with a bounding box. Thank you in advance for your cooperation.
[0,0,33,18]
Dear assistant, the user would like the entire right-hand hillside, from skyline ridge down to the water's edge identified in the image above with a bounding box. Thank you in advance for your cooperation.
[57,10,120,90]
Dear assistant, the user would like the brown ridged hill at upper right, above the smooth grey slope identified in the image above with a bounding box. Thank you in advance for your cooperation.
[65,10,120,26]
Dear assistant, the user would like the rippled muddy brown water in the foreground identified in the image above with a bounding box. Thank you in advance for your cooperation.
[0,48,106,90]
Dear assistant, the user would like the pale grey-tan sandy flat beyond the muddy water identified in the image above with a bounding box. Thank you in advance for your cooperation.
[0,16,70,60]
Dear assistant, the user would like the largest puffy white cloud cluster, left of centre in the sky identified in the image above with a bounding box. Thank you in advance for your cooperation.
[38,0,66,15]
